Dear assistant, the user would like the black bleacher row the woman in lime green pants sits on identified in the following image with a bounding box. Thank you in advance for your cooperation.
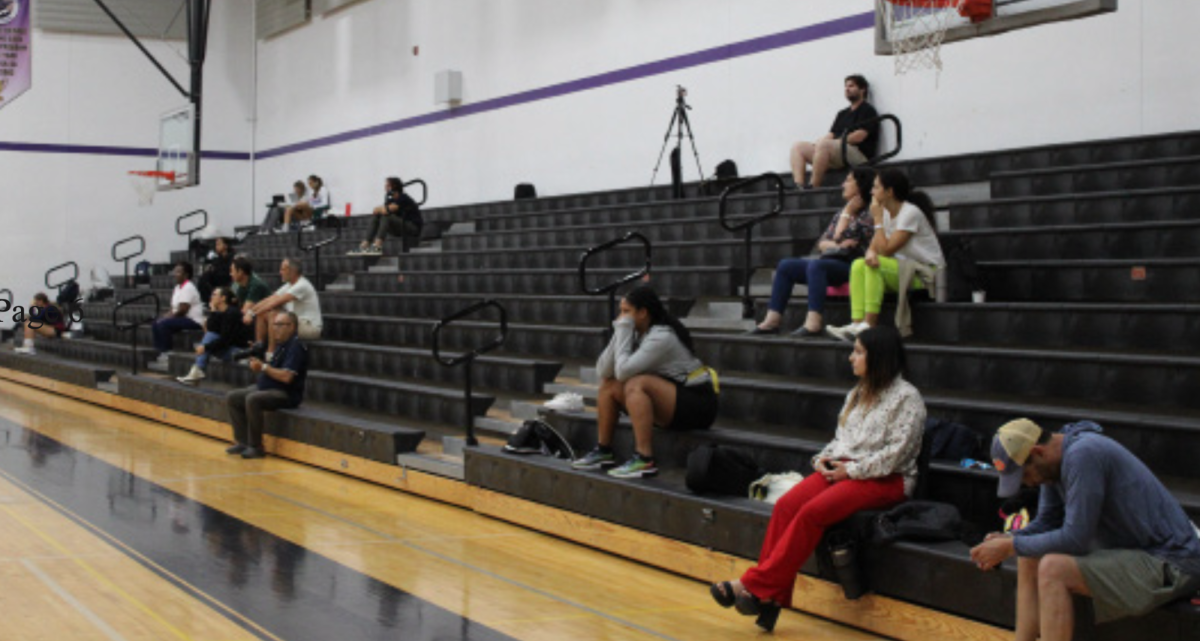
[755,296,1200,352]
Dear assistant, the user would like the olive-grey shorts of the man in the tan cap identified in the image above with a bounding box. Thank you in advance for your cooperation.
[1075,550,1200,623]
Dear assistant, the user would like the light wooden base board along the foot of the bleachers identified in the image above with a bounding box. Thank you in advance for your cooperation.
[0,367,1013,641]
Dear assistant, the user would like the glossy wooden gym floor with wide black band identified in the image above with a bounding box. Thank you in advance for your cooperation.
[0,381,881,641]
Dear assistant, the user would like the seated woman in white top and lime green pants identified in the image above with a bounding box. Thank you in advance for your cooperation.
[829,169,946,341]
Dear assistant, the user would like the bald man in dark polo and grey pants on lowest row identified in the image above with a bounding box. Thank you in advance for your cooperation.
[226,312,308,459]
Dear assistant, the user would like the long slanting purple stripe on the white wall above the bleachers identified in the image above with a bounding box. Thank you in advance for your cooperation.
[256,11,875,160]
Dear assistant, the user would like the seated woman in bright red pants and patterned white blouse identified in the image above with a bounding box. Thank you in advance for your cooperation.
[710,327,925,631]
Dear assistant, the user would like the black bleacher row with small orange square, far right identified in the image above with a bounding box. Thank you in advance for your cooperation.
[978,258,1200,302]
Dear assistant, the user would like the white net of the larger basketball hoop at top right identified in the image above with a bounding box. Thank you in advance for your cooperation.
[876,0,966,76]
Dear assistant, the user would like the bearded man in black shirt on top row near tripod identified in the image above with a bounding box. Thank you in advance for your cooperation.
[792,74,880,188]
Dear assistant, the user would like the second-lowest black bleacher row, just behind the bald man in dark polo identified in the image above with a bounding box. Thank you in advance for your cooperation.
[170,354,496,425]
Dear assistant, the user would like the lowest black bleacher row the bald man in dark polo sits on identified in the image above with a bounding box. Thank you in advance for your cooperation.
[120,376,426,465]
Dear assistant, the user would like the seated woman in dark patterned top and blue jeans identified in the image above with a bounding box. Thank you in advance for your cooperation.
[750,168,875,339]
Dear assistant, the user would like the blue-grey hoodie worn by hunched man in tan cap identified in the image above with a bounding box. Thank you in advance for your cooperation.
[1013,421,1200,576]
